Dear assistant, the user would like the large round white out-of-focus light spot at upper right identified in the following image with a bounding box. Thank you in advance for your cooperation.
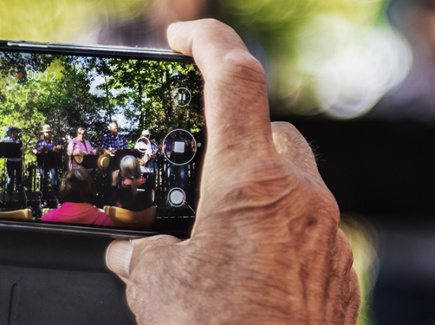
[299,15,412,118]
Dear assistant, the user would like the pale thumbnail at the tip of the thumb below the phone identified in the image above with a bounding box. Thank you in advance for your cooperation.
[106,239,134,278]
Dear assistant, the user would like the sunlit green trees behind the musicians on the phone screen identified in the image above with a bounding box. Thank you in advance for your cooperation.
[0,53,204,159]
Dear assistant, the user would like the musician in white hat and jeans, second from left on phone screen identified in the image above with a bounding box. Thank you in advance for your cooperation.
[33,125,62,208]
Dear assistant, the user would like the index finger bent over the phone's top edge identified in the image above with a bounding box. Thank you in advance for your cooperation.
[168,19,272,163]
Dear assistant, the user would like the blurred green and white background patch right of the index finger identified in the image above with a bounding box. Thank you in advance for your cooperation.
[226,0,412,119]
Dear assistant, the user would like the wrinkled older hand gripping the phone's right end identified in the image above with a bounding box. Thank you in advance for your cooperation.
[106,20,360,325]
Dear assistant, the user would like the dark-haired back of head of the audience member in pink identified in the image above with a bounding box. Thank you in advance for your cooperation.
[59,168,95,203]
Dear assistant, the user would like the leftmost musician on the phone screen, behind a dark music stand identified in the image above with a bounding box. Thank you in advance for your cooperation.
[5,127,24,201]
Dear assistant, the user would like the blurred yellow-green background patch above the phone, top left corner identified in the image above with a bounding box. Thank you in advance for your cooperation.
[0,0,147,42]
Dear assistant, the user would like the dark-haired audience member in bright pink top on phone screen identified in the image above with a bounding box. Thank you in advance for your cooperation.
[41,168,116,227]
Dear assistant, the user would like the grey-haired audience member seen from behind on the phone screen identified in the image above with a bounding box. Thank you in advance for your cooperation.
[109,156,153,211]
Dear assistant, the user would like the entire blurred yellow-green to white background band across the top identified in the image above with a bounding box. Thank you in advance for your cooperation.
[0,0,412,119]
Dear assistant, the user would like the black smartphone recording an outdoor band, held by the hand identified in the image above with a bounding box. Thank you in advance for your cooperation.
[0,41,205,237]
